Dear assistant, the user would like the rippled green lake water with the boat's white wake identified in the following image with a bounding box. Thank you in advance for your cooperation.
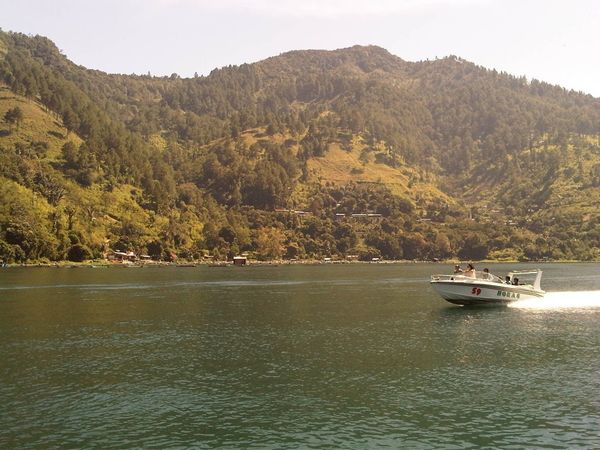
[0,264,600,449]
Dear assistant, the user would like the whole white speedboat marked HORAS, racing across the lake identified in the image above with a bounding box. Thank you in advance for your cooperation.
[431,269,545,305]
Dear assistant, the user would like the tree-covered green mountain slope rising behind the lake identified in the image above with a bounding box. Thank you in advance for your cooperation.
[0,32,600,261]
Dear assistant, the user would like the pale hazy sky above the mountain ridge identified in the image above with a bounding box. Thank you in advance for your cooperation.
[0,0,600,97]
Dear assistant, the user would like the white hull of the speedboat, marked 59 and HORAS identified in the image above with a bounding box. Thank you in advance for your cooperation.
[431,280,544,305]
